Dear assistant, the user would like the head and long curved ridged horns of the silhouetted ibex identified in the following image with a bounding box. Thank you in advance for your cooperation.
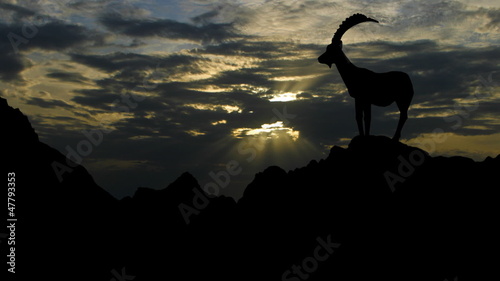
[318,14,378,68]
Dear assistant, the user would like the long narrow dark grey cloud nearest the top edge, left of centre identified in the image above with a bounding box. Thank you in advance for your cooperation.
[99,13,237,43]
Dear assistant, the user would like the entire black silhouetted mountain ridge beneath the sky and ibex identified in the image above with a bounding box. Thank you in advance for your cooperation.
[0,99,500,281]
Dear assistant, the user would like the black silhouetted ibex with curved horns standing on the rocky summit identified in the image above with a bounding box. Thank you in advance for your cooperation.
[318,14,413,140]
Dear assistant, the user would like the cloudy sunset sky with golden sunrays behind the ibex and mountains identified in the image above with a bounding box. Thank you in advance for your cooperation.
[0,0,500,198]
